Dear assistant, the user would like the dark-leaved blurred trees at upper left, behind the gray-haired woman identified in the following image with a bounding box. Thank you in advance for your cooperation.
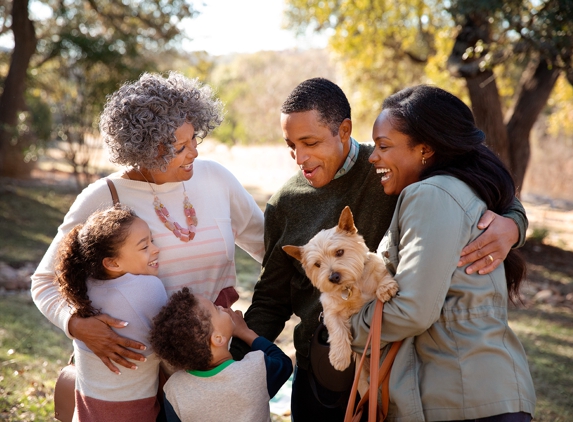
[0,0,194,177]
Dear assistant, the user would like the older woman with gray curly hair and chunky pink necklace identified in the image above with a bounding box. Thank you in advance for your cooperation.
[32,72,264,373]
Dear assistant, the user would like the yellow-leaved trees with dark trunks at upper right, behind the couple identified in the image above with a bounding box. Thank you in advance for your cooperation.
[286,0,573,193]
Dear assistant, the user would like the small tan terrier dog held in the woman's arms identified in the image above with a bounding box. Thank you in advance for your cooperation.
[283,207,398,380]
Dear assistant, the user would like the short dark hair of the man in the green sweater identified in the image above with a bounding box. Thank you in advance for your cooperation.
[281,78,351,135]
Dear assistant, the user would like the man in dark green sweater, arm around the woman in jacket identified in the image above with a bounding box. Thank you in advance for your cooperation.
[232,78,527,422]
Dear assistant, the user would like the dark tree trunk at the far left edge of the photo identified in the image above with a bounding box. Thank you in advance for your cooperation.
[0,0,37,177]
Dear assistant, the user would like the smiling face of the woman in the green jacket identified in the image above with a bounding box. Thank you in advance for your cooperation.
[369,110,431,195]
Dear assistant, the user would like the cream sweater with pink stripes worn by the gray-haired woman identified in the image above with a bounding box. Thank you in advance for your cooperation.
[32,159,264,337]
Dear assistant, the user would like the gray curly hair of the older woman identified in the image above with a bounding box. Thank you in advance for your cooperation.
[99,72,223,171]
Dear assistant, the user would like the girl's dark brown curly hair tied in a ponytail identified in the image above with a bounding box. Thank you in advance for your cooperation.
[55,205,137,318]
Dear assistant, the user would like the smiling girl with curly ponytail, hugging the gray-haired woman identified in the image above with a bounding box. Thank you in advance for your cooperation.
[55,206,167,422]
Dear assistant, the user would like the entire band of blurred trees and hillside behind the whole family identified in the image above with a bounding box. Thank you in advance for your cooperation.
[0,0,573,195]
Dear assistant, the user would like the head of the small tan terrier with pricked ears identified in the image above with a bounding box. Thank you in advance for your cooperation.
[283,207,368,293]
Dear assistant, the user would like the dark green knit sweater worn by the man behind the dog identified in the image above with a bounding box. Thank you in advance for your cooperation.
[231,144,527,369]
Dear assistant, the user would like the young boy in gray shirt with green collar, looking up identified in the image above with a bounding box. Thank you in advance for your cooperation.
[149,287,292,422]
